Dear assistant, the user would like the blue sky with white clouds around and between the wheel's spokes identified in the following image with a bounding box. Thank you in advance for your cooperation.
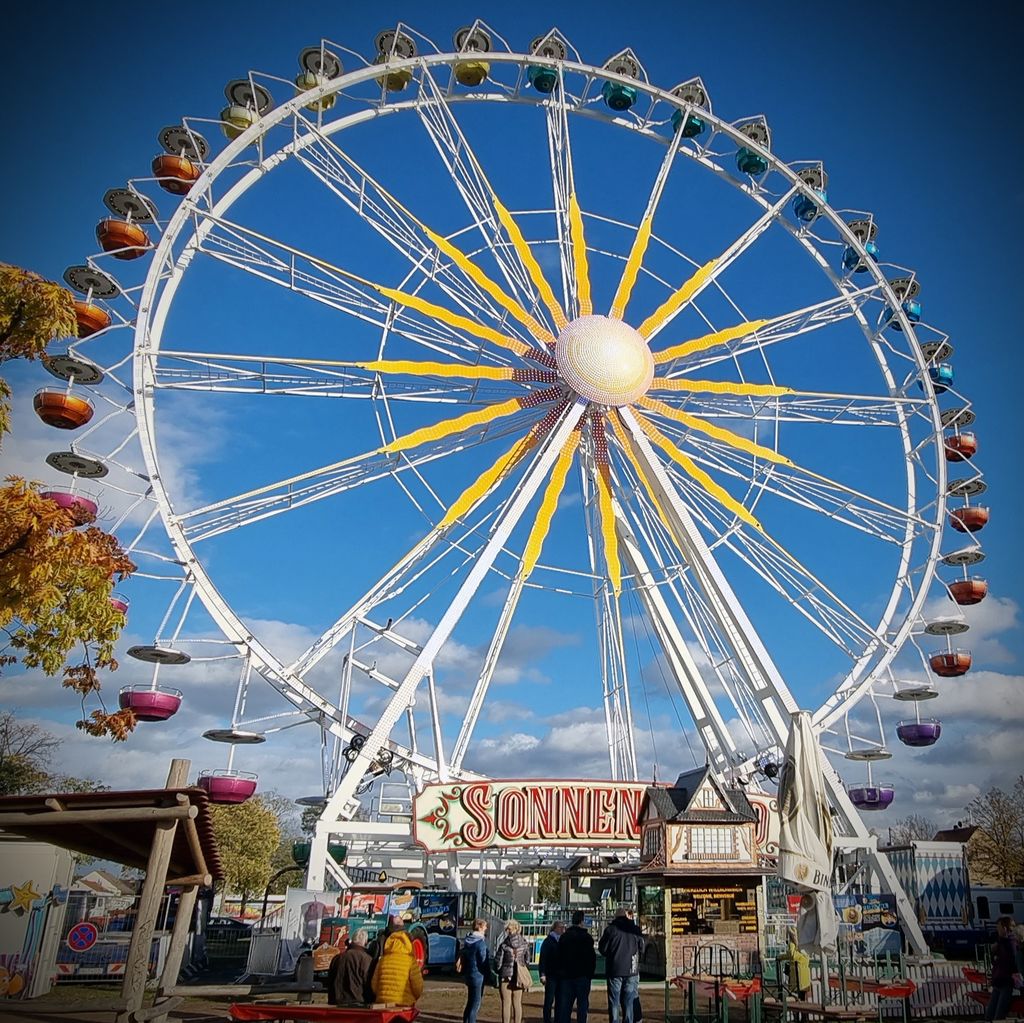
[0,3,1024,831]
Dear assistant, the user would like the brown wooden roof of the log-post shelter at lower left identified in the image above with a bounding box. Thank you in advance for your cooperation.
[0,788,224,881]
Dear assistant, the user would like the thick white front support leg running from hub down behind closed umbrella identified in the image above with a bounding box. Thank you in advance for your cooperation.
[622,409,929,955]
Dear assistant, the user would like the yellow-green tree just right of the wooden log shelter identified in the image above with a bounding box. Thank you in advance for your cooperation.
[212,796,281,912]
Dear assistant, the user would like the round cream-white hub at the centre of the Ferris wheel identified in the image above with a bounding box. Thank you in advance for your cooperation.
[555,316,654,407]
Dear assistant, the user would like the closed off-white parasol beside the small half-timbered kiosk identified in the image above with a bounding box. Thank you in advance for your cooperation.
[778,711,839,953]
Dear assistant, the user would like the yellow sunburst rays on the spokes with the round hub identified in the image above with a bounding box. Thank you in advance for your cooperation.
[315,140,821,597]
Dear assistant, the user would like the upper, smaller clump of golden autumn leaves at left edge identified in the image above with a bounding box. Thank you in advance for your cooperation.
[0,263,78,441]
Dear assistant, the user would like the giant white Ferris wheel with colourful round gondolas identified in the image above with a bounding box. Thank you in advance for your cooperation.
[36,22,988,946]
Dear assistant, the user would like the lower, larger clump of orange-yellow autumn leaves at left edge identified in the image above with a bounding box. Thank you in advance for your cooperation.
[0,476,135,739]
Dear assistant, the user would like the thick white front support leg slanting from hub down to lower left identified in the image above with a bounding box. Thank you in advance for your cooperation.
[306,399,586,888]
